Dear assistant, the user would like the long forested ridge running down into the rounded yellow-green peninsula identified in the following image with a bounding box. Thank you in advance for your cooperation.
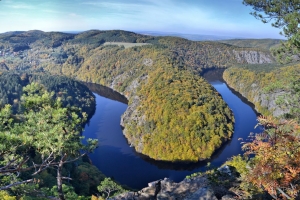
[0,30,274,162]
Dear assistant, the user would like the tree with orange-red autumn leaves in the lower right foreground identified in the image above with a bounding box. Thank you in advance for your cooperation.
[243,117,300,199]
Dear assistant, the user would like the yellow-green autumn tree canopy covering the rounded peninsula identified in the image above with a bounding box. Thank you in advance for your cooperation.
[126,67,233,162]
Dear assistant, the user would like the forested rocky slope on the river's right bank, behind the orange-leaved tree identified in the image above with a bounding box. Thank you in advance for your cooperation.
[223,62,300,121]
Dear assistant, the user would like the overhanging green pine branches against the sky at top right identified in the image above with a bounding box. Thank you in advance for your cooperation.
[243,0,300,62]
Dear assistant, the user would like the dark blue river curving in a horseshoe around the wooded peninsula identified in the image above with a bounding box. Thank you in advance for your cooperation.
[83,70,260,189]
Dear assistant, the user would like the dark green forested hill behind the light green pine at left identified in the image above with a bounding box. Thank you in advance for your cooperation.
[0,72,96,117]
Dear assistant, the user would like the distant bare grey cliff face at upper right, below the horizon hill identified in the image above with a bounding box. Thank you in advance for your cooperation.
[233,50,274,64]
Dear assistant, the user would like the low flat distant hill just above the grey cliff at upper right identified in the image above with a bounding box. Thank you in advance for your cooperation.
[218,39,284,50]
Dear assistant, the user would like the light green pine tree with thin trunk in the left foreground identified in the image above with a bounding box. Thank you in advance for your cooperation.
[0,83,97,199]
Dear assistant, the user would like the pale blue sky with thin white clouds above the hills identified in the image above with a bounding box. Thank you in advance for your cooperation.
[0,0,283,39]
